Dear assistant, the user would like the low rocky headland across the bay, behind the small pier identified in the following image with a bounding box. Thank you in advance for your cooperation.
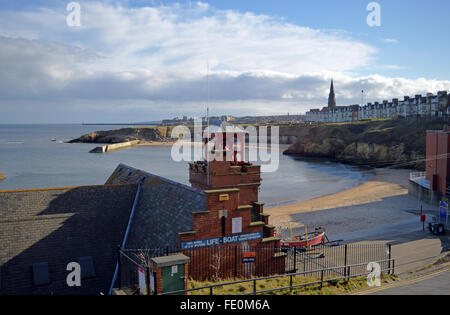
[70,128,166,143]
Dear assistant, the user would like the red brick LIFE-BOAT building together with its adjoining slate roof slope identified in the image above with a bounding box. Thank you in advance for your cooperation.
[107,132,285,279]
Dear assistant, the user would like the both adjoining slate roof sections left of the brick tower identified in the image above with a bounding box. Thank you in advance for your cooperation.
[0,164,206,295]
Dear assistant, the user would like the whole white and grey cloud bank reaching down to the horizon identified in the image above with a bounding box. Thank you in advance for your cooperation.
[0,2,450,122]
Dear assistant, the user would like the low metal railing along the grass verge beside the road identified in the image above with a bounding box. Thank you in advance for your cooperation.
[158,259,395,295]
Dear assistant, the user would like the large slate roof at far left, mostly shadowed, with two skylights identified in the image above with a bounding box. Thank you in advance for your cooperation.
[0,185,137,295]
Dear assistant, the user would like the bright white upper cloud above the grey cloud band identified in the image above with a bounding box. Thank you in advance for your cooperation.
[0,2,376,74]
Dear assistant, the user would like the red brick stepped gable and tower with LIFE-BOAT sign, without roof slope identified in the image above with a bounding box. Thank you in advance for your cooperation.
[179,133,285,278]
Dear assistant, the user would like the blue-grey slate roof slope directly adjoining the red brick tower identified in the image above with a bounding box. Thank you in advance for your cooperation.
[107,164,206,249]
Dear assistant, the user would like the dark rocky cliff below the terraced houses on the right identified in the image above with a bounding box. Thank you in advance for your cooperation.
[284,120,445,169]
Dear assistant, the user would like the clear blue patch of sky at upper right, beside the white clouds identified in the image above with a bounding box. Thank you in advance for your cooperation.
[157,0,450,80]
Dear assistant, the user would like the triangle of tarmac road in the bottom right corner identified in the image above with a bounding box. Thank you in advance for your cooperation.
[371,269,450,295]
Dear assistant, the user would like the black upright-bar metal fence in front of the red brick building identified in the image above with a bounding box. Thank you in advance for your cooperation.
[118,242,391,281]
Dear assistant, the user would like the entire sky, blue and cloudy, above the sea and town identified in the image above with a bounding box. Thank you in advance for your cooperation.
[0,0,450,123]
